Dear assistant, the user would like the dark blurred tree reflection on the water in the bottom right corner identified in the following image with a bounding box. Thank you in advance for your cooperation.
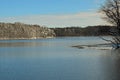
[103,50,120,80]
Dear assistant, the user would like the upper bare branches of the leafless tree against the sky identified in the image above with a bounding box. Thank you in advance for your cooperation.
[100,0,120,35]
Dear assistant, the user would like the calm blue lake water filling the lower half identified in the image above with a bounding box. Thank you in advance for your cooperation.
[0,37,120,80]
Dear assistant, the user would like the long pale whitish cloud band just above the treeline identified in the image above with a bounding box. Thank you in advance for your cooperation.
[0,12,106,27]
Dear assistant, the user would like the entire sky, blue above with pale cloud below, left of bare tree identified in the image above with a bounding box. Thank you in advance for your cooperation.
[0,0,107,27]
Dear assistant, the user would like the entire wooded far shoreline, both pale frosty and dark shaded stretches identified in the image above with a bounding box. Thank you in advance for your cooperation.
[0,22,115,39]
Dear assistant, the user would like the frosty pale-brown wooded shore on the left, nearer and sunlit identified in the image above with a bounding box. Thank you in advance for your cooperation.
[0,22,55,39]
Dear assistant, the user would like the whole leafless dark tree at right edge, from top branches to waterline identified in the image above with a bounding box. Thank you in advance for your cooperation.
[100,0,120,48]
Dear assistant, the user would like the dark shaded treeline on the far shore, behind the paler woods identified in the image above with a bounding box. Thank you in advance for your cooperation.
[51,26,115,37]
